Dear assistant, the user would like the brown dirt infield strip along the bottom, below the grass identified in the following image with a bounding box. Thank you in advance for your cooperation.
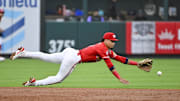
[0,87,180,101]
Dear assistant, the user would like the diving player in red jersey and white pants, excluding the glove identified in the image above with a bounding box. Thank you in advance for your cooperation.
[10,32,152,86]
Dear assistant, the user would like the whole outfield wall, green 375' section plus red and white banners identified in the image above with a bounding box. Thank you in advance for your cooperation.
[41,21,180,55]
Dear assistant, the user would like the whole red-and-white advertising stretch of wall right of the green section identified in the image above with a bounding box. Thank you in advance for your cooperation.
[126,22,180,54]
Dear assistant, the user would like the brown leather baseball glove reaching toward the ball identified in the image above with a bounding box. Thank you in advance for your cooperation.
[137,58,153,72]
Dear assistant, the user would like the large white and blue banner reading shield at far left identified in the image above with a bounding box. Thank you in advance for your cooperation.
[0,0,41,53]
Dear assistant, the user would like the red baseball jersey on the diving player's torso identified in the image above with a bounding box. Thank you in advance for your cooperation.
[80,42,113,67]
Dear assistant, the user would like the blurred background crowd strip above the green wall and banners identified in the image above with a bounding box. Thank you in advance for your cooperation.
[46,0,180,22]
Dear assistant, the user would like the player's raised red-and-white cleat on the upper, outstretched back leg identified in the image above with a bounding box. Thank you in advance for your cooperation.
[10,47,24,60]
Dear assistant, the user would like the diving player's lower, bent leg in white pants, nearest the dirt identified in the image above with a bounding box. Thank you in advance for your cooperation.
[25,49,81,86]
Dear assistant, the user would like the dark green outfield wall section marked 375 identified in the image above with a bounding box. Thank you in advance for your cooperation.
[41,21,125,54]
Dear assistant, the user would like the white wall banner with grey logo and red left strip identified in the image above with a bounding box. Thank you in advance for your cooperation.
[126,22,155,54]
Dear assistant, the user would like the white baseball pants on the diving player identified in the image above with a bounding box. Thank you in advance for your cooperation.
[22,48,81,86]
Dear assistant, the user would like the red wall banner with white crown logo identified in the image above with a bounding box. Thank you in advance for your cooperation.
[156,22,177,54]
